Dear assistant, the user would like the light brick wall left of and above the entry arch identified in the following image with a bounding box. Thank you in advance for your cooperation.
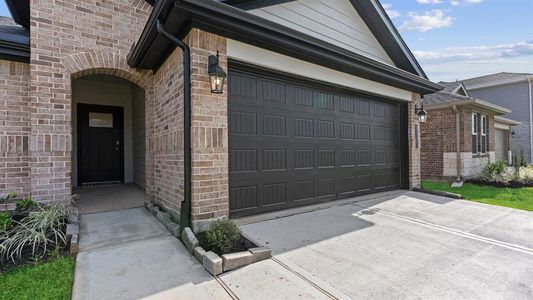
[29,0,151,201]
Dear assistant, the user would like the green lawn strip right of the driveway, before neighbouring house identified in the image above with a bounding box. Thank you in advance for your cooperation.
[422,181,533,211]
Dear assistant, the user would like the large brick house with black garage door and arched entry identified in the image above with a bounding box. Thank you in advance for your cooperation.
[0,0,442,229]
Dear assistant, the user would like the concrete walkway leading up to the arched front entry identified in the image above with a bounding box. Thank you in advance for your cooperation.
[72,208,231,300]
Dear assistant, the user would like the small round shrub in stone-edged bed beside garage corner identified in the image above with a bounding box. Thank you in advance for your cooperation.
[198,219,241,255]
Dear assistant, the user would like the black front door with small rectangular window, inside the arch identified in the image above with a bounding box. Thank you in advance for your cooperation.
[78,104,124,185]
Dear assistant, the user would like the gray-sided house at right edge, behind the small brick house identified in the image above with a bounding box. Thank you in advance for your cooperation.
[462,73,533,163]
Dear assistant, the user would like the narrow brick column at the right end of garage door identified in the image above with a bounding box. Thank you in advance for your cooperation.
[407,93,420,189]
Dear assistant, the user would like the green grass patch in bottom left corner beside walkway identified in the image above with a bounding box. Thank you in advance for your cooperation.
[0,257,74,300]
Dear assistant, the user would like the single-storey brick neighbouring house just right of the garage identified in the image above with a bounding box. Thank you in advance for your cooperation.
[421,82,520,178]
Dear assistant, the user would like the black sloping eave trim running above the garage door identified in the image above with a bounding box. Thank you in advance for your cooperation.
[127,0,442,94]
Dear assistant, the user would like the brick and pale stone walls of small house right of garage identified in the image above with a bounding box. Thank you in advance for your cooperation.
[421,106,495,178]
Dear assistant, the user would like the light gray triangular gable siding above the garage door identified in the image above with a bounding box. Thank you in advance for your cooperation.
[250,0,394,65]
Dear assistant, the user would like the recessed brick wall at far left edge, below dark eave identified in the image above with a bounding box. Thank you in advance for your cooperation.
[0,60,30,196]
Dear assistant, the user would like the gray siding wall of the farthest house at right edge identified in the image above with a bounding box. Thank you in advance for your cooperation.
[467,82,531,162]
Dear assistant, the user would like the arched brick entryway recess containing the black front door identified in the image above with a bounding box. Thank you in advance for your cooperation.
[71,72,147,213]
